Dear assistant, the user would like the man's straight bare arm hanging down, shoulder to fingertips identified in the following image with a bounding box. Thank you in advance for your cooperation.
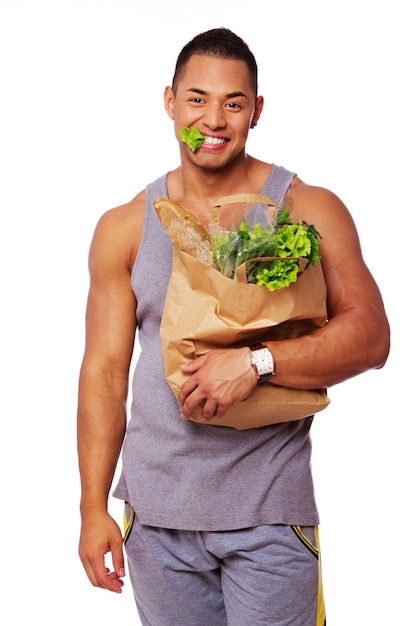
[77,197,139,592]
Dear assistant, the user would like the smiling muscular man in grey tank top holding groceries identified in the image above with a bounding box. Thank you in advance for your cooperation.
[78,29,389,626]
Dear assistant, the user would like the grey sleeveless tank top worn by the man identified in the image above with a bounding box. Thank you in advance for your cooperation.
[114,165,319,531]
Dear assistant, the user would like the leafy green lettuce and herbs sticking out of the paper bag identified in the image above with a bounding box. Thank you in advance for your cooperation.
[212,210,321,291]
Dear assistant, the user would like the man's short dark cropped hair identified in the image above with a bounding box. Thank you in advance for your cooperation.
[172,28,258,97]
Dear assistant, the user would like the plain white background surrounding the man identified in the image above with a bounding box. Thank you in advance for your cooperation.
[0,0,417,626]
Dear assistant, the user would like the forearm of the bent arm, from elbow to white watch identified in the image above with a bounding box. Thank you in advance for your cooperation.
[265,311,389,389]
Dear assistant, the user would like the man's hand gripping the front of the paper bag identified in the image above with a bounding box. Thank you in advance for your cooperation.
[178,347,257,421]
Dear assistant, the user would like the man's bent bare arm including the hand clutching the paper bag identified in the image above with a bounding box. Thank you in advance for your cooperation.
[179,180,389,418]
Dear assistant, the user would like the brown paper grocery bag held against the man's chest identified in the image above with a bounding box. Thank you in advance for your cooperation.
[161,196,330,430]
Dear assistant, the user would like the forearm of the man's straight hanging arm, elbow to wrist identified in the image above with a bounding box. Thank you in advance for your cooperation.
[77,372,127,516]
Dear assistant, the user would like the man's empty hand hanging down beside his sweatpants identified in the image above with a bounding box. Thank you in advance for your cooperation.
[79,513,125,593]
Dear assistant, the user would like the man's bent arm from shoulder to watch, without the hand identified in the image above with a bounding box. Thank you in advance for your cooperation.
[268,178,389,389]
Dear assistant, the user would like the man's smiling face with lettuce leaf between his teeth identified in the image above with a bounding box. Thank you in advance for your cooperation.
[165,55,262,169]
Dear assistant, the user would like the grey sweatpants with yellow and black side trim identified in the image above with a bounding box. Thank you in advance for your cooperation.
[125,510,325,626]
